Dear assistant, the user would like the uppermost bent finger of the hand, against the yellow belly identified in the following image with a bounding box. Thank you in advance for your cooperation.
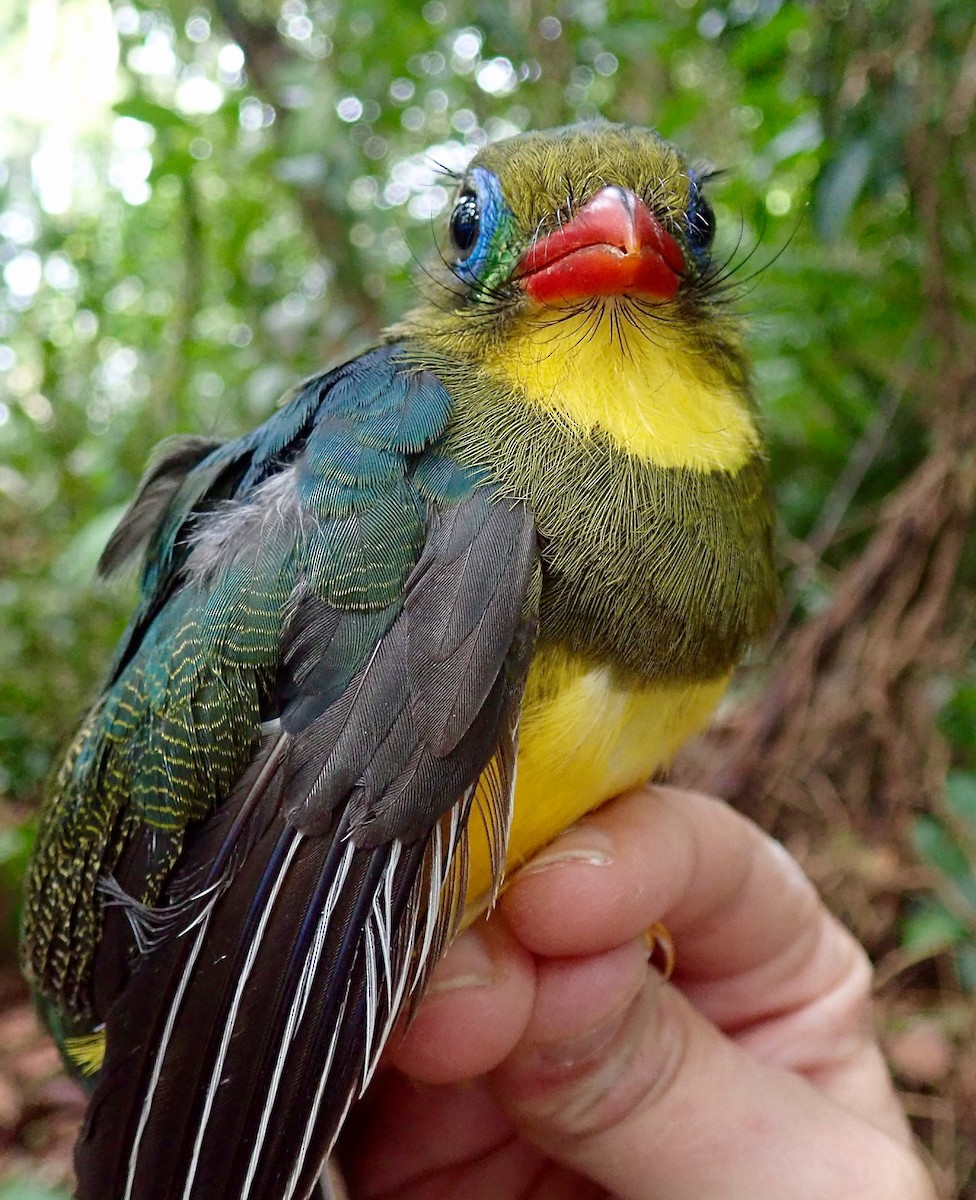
[503,787,910,1141]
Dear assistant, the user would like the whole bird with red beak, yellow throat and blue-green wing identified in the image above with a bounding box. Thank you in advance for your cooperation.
[22,121,777,1200]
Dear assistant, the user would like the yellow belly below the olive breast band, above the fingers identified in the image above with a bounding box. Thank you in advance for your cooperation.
[466,652,729,919]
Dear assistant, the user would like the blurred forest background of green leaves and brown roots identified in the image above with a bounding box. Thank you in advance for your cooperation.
[0,0,976,1200]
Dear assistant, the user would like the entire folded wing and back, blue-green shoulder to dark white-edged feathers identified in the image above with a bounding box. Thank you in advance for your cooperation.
[24,346,538,1200]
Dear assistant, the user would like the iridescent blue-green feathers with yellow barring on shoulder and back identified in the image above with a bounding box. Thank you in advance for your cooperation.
[25,347,463,1020]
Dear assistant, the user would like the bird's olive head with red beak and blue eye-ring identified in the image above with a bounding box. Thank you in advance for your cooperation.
[391,122,741,384]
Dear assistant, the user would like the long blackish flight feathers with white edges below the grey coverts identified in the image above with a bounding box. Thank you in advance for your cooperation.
[76,793,471,1200]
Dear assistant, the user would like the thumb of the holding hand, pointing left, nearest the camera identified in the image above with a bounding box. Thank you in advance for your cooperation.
[492,962,934,1200]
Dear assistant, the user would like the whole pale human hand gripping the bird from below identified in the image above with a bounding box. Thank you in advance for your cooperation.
[341,787,935,1200]
